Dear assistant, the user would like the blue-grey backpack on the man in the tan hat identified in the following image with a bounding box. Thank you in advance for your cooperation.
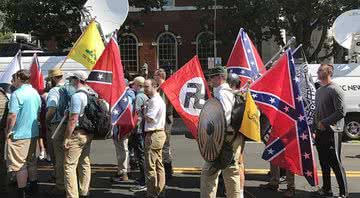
[57,85,76,118]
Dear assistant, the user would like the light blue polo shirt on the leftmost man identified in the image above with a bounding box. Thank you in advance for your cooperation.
[9,84,41,140]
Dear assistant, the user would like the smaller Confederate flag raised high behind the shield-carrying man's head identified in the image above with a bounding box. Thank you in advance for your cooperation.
[226,28,265,85]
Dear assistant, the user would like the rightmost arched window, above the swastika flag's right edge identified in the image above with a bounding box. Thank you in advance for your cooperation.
[196,32,214,71]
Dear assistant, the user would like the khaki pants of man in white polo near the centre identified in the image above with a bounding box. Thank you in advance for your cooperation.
[145,131,166,197]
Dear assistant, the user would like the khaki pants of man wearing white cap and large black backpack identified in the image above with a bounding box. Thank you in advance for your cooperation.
[64,130,93,198]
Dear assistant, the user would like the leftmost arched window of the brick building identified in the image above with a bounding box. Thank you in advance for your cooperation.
[119,33,139,73]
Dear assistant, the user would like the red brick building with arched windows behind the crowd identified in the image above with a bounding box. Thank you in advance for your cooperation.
[119,0,236,77]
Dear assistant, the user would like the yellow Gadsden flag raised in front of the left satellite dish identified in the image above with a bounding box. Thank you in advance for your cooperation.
[68,21,105,70]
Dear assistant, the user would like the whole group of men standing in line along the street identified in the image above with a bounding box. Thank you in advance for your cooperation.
[2,64,348,198]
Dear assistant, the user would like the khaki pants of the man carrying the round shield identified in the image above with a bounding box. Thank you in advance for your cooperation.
[200,135,243,198]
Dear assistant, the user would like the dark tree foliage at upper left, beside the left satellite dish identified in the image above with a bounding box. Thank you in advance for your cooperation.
[0,0,163,48]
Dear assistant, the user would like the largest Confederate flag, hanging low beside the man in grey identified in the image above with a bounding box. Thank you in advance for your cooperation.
[250,50,318,186]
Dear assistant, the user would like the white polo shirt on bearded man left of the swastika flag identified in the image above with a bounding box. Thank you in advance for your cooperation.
[145,93,166,132]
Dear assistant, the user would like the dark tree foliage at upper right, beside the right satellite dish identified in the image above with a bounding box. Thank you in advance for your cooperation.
[197,0,360,61]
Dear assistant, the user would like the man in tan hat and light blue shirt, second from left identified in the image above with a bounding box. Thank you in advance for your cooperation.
[45,68,66,195]
